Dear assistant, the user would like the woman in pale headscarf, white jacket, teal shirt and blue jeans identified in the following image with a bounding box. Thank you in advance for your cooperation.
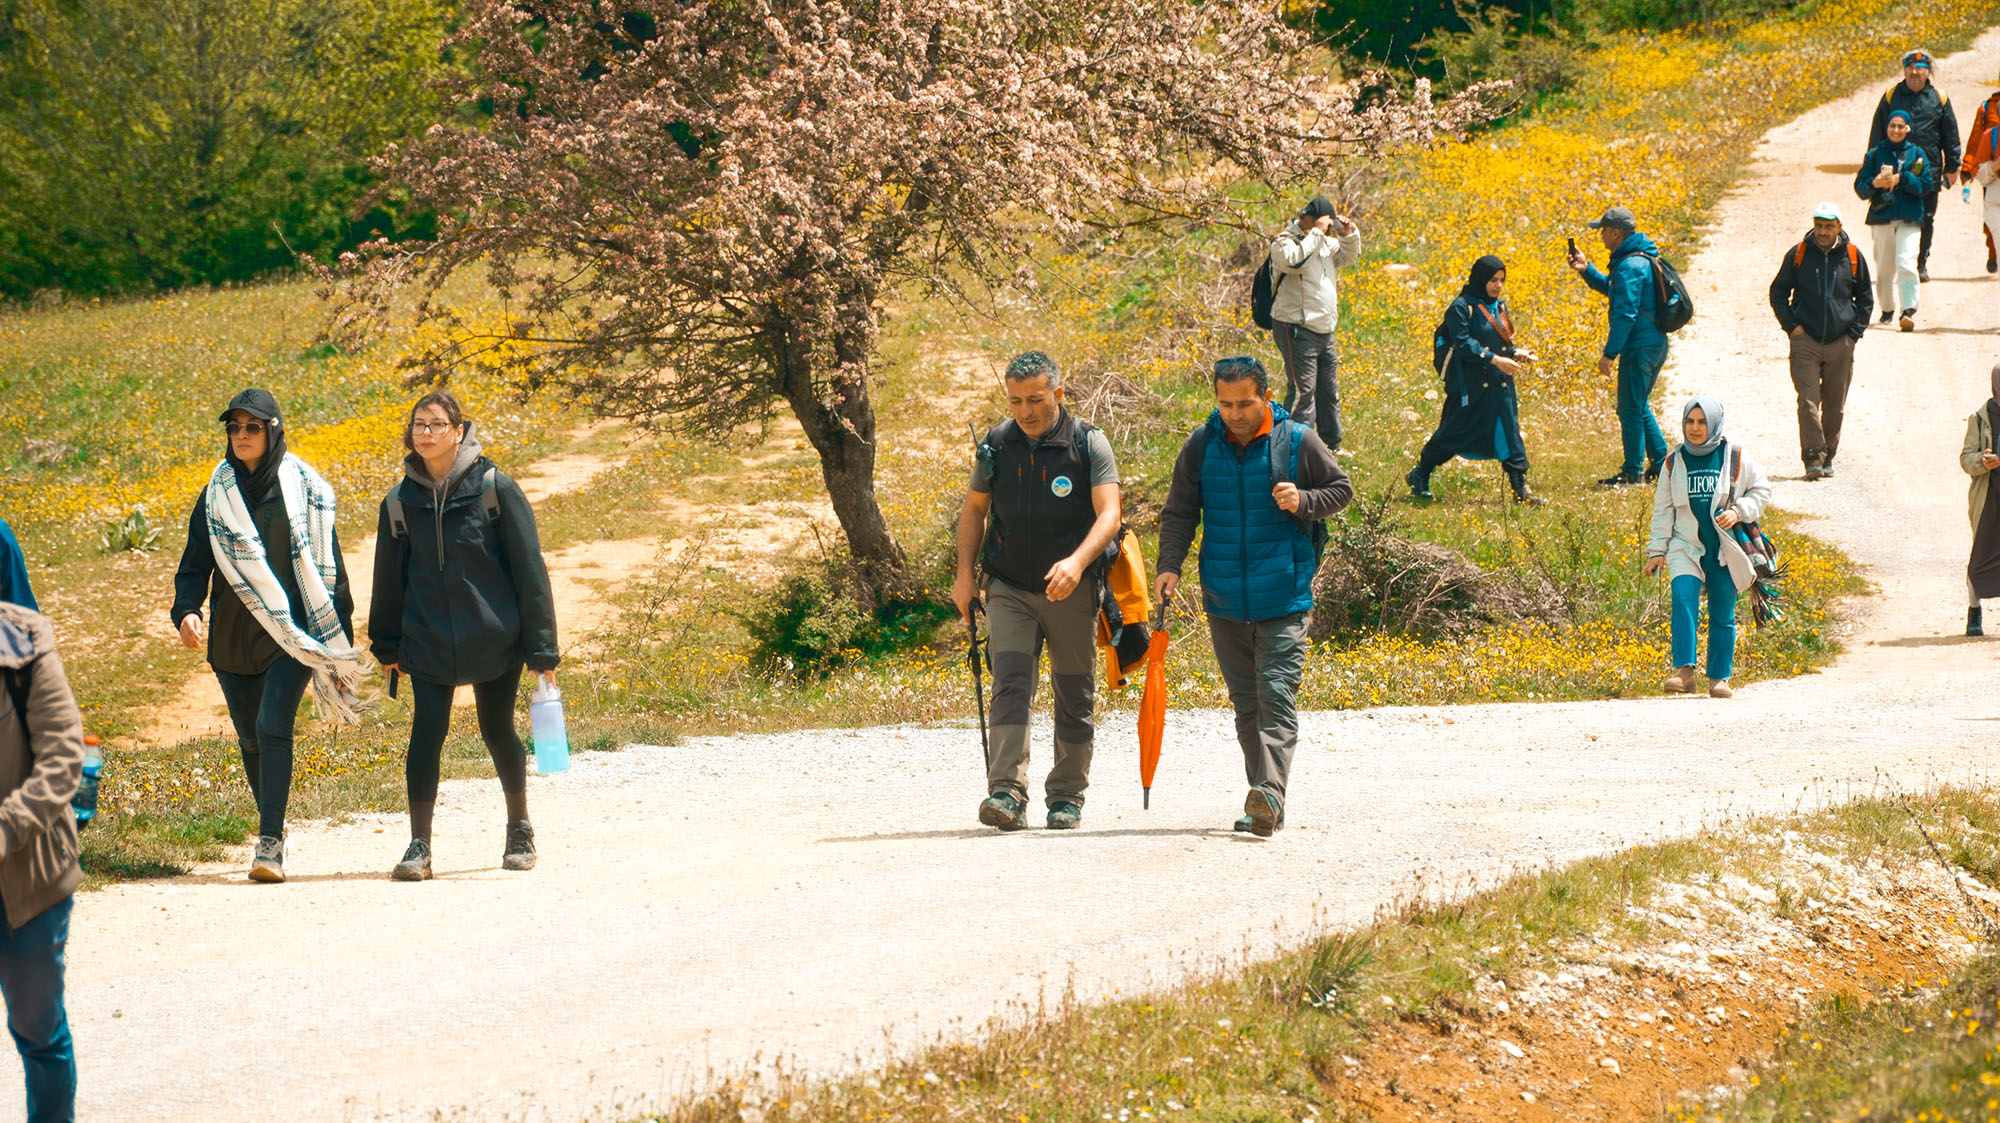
[1640,396,1770,697]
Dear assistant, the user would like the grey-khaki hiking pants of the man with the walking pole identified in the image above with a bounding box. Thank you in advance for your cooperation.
[986,577,1098,807]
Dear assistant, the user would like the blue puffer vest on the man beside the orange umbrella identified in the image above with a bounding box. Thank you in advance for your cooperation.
[1202,404,1318,623]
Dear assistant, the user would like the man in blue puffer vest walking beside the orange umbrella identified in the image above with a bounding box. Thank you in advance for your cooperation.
[1154,356,1354,837]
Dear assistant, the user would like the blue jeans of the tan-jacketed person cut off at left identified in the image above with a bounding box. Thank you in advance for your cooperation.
[0,897,76,1123]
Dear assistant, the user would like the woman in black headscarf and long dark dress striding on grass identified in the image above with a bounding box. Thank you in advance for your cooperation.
[1404,254,1542,506]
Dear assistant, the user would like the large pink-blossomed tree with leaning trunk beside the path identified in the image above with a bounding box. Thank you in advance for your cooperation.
[348,0,1482,589]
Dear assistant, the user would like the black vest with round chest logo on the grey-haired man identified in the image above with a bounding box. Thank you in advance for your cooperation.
[982,410,1098,593]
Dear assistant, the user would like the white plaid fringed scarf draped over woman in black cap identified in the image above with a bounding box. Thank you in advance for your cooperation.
[208,454,360,725]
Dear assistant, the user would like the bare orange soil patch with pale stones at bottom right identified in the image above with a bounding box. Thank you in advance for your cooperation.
[1320,831,2000,1123]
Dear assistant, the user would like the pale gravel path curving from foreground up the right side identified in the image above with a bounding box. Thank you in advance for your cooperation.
[27,34,2000,1123]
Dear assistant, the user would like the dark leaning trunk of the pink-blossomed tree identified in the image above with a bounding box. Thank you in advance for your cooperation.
[774,305,910,601]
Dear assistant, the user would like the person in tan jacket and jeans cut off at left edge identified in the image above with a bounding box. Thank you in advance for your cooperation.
[0,601,84,1123]
